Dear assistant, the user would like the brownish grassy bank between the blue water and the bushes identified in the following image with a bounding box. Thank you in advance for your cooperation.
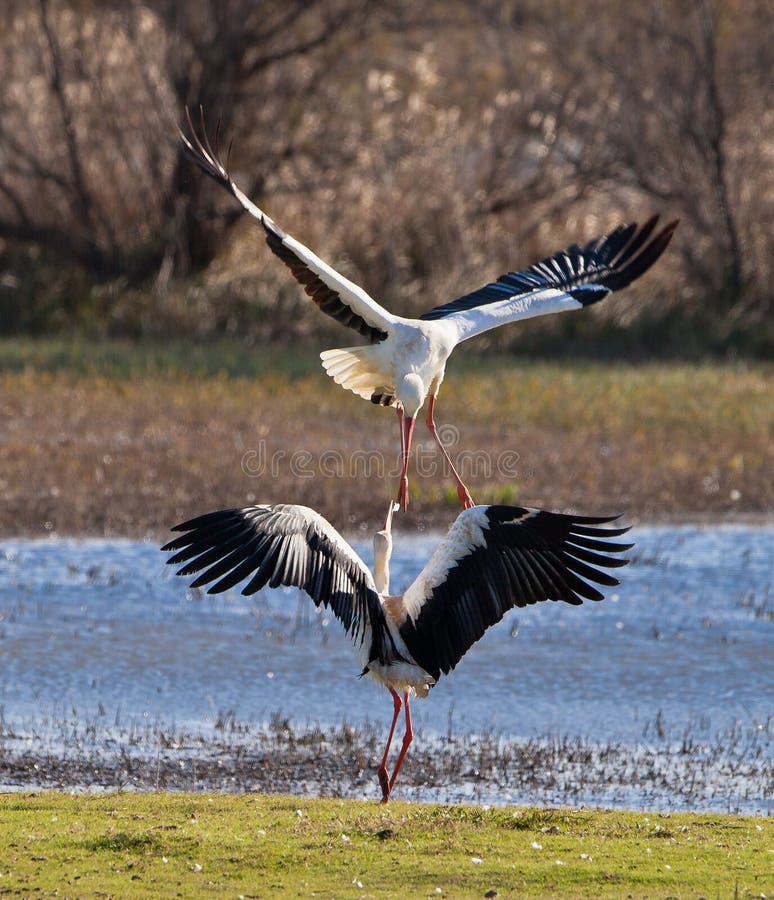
[0,341,774,536]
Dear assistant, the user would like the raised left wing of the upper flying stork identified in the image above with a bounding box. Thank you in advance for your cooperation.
[180,108,396,343]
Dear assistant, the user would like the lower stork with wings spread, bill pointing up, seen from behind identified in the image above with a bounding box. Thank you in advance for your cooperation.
[161,504,633,803]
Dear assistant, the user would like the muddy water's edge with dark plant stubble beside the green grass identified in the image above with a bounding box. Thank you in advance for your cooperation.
[0,720,774,815]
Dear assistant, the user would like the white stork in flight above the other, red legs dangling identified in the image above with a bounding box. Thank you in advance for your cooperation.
[180,109,677,510]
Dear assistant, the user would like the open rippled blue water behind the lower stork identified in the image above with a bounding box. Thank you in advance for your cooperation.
[0,526,774,808]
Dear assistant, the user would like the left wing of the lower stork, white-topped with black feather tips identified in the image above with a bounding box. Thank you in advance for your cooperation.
[161,504,394,658]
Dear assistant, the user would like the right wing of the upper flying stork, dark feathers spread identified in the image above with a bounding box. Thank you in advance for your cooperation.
[420,216,677,341]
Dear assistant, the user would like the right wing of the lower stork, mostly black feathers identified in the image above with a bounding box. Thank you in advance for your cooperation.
[400,506,633,679]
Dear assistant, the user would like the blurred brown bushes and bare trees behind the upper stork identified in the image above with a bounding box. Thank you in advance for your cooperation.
[0,0,774,357]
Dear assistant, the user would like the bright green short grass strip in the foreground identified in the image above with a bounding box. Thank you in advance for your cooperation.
[0,793,774,898]
